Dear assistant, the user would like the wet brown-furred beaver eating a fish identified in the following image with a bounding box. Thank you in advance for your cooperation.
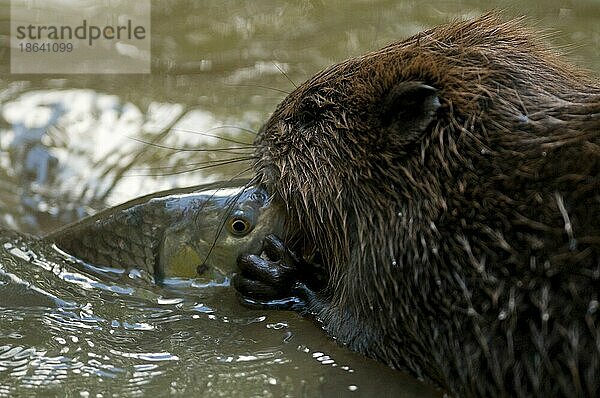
[234,13,600,397]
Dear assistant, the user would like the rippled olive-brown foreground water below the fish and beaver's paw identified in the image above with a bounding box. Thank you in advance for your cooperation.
[0,231,440,396]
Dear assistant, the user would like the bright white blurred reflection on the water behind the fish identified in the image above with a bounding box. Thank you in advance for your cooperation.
[0,89,251,234]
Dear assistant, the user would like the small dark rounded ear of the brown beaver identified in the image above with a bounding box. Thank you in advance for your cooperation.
[381,82,441,141]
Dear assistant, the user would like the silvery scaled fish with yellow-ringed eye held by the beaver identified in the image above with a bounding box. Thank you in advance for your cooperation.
[42,180,284,283]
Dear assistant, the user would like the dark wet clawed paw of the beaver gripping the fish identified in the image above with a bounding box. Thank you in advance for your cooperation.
[233,235,299,307]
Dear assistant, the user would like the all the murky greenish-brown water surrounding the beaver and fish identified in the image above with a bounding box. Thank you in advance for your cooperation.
[0,0,600,397]
